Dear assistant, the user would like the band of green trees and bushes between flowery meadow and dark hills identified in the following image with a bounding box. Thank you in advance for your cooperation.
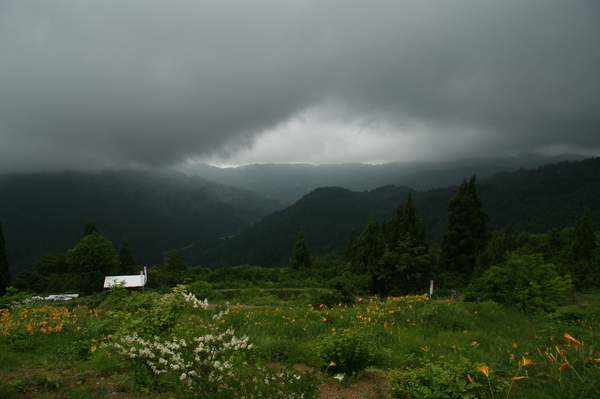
[0,175,600,311]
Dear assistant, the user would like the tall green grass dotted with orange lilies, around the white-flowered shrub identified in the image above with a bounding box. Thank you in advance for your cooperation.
[0,291,600,398]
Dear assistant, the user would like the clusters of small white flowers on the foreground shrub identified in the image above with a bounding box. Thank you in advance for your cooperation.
[112,291,314,398]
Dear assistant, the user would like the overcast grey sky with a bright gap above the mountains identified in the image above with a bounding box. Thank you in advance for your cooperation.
[0,0,600,172]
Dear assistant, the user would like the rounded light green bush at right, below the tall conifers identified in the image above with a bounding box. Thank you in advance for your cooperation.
[465,254,572,313]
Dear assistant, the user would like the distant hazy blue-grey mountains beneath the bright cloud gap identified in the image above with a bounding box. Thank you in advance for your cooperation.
[180,154,584,205]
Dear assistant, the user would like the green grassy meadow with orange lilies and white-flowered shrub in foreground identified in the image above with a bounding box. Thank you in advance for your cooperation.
[0,286,600,399]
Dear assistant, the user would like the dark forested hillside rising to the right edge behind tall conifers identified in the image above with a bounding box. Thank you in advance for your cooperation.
[205,158,600,266]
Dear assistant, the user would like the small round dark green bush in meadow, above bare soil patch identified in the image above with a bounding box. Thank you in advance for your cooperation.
[318,330,375,375]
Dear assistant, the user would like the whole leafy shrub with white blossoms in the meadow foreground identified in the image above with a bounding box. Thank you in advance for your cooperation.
[106,287,316,398]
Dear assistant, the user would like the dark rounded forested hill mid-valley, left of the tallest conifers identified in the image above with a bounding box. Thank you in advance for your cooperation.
[197,186,410,267]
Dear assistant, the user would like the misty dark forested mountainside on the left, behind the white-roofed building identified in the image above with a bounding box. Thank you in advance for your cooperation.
[0,170,280,274]
